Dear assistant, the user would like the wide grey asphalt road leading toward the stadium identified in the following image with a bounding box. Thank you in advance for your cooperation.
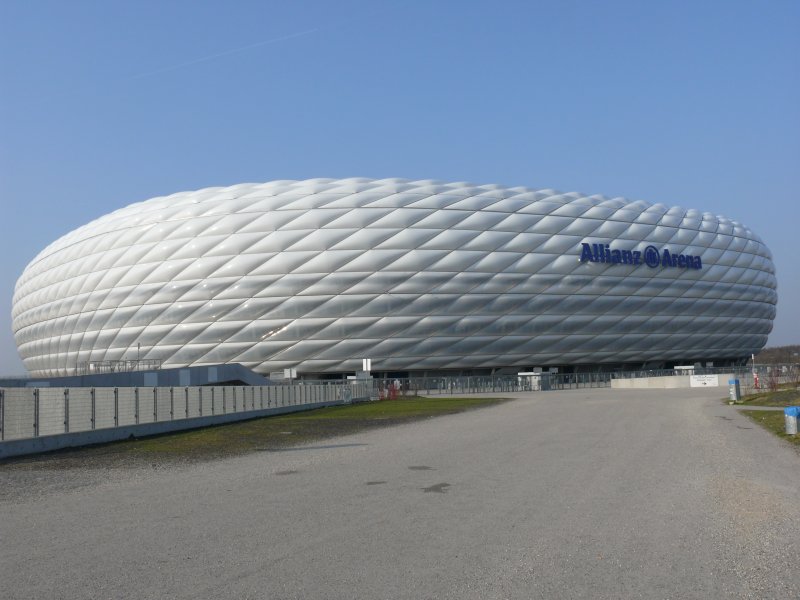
[0,389,800,600]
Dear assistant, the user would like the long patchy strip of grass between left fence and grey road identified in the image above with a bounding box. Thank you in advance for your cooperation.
[3,396,505,468]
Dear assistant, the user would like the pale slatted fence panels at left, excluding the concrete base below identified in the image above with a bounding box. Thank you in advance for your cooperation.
[0,382,372,441]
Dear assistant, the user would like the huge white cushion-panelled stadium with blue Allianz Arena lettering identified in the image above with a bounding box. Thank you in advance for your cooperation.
[13,178,777,377]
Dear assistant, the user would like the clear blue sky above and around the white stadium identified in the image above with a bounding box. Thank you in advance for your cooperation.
[0,0,800,374]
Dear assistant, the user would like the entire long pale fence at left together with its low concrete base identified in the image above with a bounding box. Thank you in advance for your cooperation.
[0,382,372,458]
